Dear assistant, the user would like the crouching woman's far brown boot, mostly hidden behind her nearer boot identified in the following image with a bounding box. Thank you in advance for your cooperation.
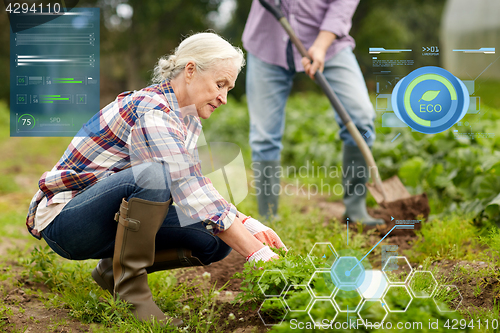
[92,249,205,294]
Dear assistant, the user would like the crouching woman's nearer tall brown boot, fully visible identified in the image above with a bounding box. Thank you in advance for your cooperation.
[113,198,179,325]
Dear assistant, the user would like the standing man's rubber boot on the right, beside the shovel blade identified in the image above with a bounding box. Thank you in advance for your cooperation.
[342,145,385,226]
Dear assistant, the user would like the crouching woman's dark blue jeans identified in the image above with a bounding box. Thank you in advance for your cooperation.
[41,163,231,265]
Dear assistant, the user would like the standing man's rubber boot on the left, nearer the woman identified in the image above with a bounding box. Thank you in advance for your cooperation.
[252,161,281,221]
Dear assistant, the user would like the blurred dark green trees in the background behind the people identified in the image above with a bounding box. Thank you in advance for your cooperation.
[0,0,445,102]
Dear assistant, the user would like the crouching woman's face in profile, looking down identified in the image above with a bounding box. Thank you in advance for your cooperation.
[187,61,238,119]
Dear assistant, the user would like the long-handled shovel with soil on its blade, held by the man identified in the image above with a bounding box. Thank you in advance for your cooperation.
[259,0,430,229]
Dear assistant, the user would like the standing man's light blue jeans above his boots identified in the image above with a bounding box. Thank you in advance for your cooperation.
[246,47,375,161]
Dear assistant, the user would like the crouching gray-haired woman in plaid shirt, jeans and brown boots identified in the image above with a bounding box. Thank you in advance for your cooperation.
[26,33,284,325]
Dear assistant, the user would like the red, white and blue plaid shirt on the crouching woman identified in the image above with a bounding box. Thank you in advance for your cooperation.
[26,81,238,239]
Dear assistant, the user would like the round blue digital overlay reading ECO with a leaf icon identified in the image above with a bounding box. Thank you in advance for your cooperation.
[368,45,498,142]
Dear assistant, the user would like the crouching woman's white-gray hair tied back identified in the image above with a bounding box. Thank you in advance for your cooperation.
[153,32,245,83]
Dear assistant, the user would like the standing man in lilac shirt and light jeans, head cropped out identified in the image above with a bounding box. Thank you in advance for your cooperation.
[243,0,384,225]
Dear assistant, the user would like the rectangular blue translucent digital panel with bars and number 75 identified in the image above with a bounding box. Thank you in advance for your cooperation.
[10,8,100,137]
